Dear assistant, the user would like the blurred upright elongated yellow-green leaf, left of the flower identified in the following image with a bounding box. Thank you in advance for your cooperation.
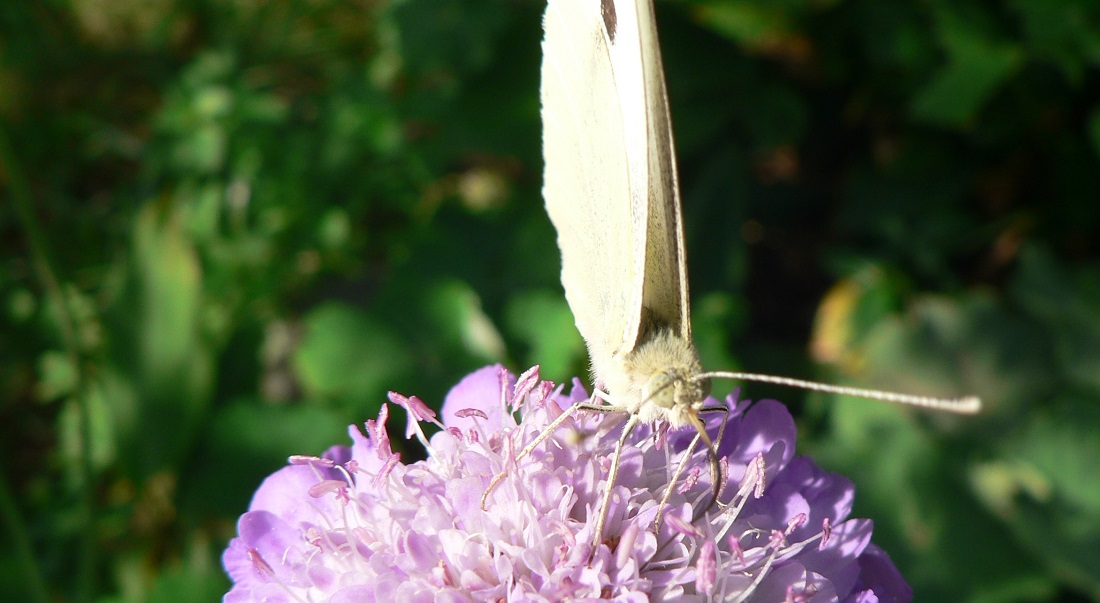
[108,202,215,475]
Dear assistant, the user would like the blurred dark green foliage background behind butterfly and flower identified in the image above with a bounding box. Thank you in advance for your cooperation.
[0,0,1100,603]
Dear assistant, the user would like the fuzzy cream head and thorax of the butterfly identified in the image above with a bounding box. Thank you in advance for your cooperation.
[593,328,711,428]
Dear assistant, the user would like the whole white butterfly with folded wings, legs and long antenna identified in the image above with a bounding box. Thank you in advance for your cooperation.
[482,0,980,545]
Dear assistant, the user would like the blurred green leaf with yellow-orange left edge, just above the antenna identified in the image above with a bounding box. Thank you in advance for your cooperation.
[813,279,1056,411]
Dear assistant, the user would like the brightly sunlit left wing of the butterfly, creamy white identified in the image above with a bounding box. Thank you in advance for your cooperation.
[541,0,640,363]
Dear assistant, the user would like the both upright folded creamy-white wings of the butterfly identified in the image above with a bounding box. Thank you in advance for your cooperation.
[542,0,691,379]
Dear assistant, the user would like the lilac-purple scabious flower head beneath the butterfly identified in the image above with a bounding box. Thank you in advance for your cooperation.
[222,366,912,603]
